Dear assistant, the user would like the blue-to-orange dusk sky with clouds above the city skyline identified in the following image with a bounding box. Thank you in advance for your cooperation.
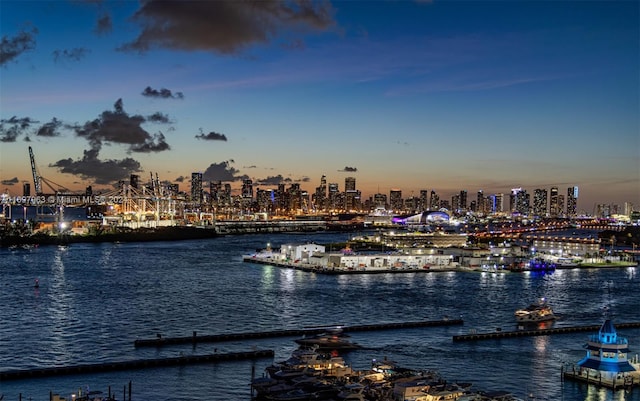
[0,0,640,213]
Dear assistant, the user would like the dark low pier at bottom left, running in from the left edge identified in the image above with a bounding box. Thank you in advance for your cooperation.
[0,350,274,381]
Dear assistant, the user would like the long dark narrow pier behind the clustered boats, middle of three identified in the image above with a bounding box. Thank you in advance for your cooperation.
[134,319,464,347]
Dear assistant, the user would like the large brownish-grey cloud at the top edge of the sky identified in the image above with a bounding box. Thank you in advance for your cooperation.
[120,0,334,54]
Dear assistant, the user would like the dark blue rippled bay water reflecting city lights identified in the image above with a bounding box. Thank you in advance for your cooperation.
[0,233,640,401]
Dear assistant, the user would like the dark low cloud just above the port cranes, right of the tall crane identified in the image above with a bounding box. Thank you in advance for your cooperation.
[49,149,142,185]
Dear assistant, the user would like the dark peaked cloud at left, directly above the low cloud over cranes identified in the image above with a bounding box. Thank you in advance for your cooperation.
[76,99,170,152]
